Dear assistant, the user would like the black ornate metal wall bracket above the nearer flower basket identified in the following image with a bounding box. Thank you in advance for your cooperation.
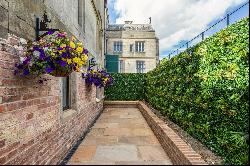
[36,12,59,41]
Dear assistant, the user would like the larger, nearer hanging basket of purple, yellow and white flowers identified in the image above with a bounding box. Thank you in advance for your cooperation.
[15,31,88,77]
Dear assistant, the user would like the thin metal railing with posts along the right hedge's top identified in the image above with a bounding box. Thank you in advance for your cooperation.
[168,1,249,59]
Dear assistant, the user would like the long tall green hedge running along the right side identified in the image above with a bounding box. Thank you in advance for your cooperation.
[146,18,249,164]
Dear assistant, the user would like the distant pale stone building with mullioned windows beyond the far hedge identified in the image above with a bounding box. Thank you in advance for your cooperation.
[106,21,159,73]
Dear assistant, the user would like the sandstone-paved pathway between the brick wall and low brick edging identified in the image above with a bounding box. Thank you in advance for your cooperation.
[68,108,172,165]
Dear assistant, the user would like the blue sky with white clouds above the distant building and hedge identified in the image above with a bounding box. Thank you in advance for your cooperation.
[108,0,249,59]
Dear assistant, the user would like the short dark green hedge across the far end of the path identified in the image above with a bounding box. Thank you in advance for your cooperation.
[105,73,146,101]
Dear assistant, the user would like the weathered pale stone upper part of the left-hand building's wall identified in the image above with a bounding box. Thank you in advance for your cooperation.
[0,0,106,67]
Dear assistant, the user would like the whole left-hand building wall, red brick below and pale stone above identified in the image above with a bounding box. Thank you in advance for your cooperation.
[0,0,108,165]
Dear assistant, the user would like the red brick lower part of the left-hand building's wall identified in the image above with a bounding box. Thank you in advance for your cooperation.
[0,35,103,165]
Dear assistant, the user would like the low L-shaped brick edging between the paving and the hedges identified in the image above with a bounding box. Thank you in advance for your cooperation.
[104,101,208,165]
